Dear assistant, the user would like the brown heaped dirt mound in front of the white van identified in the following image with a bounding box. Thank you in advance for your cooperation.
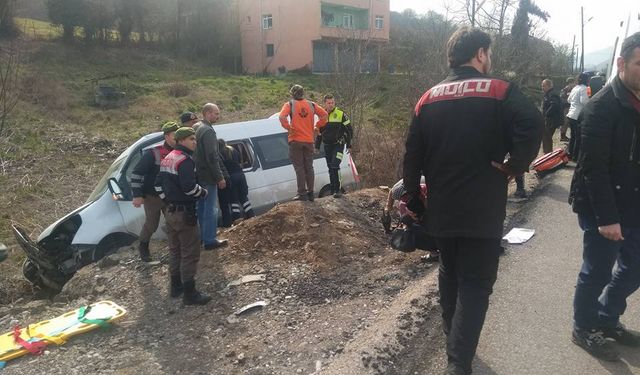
[226,189,385,270]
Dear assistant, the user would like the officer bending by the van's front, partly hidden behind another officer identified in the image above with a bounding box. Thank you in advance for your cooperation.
[131,122,178,262]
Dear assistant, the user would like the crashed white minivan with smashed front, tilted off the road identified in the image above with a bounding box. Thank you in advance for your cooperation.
[12,116,359,292]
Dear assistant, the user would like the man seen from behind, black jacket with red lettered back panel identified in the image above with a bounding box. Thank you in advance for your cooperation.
[403,27,543,375]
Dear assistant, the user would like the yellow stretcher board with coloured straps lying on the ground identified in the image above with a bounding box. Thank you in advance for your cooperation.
[0,301,127,362]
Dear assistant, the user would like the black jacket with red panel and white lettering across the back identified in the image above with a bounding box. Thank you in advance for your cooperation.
[403,67,544,238]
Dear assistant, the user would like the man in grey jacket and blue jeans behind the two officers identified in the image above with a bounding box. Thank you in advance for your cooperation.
[193,103,228,250]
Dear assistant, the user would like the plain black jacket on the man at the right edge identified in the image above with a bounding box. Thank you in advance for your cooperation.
[569,77,640,228]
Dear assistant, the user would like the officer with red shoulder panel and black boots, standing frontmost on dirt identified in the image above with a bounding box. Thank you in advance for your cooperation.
[156,127,211,305]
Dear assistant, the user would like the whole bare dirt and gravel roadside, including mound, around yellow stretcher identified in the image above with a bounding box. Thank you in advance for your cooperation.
[0,189,430,375]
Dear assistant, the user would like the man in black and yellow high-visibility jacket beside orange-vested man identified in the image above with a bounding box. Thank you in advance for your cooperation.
[316,94,353,198]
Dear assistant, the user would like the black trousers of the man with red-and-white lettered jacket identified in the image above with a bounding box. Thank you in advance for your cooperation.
[436,238,501,374]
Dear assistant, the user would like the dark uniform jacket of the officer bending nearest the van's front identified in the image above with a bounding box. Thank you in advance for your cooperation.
[131,142,173,198]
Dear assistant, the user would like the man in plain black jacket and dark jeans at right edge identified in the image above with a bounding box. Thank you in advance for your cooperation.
[569,33,640,361]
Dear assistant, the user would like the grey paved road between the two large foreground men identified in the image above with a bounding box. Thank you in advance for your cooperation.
[474,168,640,375]
